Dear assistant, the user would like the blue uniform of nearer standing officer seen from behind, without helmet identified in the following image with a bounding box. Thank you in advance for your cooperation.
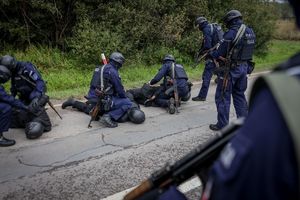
[210,19,255,129]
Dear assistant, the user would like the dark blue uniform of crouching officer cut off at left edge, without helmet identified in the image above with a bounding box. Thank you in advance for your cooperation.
[0,85,27,133]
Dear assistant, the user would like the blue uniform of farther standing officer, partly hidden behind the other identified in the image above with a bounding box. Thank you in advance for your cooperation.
[198,22,219,99]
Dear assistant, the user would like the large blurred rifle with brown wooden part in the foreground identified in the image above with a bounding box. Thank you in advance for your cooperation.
[124,118,244,200]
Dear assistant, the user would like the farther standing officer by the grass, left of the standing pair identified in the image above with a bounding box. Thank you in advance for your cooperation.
[192,17,223,101]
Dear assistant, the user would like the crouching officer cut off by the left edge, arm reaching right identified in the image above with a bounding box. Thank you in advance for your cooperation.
[0,65,35,147]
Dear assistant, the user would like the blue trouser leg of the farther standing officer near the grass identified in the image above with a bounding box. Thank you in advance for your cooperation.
[198,59,216,98]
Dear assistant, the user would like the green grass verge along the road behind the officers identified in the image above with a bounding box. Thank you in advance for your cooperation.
[2,40,300,99]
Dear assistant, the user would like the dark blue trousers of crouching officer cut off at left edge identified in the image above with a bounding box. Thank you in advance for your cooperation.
[0,102,12,133]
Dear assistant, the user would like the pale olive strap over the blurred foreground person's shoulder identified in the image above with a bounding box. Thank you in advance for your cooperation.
[250,66,300,191]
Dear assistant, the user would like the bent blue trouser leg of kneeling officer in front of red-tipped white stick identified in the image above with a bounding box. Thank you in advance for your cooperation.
[108,96,132,121]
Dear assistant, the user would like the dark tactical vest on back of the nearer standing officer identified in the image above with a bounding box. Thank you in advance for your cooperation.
[231,27,256,61]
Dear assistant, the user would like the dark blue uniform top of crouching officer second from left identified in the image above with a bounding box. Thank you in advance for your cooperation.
[11,62,46,104]
